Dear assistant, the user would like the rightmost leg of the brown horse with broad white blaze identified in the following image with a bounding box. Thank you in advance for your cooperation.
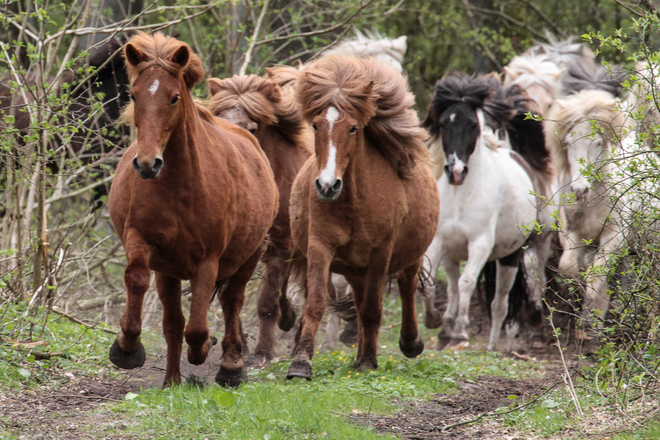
[397,262,424,358]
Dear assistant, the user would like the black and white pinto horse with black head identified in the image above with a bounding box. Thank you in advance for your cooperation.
[424,76,551,350]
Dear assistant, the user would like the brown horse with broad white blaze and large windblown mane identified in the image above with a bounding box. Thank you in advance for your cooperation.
[287,55,439,379]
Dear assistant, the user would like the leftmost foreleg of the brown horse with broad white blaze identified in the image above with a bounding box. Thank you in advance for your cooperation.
[286,246,333,380]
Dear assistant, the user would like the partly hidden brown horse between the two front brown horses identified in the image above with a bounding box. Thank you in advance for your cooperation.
[208,75,313,366]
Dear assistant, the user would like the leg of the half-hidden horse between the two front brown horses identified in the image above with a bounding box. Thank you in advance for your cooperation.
[250,257,288,367]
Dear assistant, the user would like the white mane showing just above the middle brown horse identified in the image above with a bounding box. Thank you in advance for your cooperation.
[323,29,408,72]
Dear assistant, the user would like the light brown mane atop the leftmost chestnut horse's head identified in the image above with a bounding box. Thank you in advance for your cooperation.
[126,32,205,90]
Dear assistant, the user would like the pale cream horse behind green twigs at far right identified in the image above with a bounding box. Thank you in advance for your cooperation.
[546,90,634,324]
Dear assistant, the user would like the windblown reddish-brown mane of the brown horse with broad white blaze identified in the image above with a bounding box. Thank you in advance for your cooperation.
[297,55,428,177]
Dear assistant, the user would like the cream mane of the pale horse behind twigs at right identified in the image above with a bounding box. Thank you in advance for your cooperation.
[545,90,626,175]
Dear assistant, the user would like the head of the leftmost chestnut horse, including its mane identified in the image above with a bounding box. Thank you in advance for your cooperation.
[124,34,204,179]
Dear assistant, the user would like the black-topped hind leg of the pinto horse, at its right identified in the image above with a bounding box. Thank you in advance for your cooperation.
[488,248,523,351]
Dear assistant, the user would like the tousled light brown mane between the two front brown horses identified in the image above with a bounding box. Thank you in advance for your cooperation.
[208,75,304,144]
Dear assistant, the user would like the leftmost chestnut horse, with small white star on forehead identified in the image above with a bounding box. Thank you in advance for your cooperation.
[109,33,278,386]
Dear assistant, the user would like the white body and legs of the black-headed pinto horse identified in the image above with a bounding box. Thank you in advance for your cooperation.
[427,111,537,350]
